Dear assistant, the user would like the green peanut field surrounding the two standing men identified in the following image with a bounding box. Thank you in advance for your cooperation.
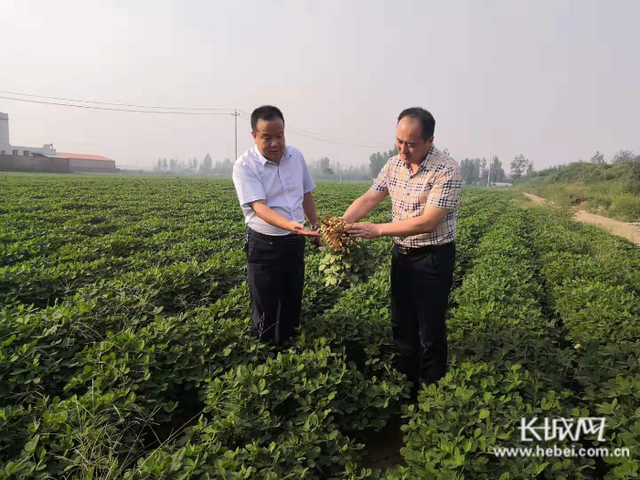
[0,174,640,480]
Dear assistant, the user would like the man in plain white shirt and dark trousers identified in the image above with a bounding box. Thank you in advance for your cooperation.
[233,105,319,345]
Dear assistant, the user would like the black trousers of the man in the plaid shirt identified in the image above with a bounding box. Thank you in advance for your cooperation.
[391,242,456,393]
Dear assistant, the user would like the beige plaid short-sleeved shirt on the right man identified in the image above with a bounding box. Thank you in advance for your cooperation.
[371,146,462,248]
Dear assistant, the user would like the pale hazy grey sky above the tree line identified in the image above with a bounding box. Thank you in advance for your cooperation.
[0,0,640,170]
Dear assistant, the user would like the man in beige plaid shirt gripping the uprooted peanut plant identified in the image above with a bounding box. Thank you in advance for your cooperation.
[343,108,462,398]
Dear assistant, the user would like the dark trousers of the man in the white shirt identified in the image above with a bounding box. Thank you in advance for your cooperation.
[245,229,305,345]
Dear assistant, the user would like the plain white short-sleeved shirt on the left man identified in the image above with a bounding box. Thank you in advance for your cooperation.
[233,145,316,235]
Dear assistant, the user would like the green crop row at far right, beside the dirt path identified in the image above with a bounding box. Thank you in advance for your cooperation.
[532,205,640,478]
